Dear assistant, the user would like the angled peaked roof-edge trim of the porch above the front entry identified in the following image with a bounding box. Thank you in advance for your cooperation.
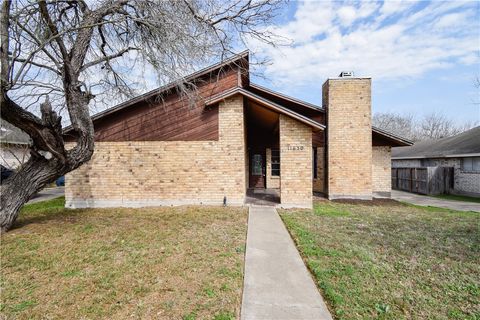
[205,87,325,131]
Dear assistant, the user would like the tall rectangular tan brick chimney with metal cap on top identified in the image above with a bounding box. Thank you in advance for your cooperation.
[322,72,372,200]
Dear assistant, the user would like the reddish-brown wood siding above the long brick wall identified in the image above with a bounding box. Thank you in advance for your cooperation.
[66,68,238,142]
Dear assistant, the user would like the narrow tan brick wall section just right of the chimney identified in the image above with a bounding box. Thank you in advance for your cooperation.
[372,147,392,198]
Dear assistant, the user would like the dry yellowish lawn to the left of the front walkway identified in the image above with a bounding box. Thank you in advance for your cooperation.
[0,198,247,320]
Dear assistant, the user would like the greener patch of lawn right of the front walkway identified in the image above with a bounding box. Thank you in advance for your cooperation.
[281,201,480,320]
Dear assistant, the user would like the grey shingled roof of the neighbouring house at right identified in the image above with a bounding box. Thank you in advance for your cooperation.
[392,126,480,159]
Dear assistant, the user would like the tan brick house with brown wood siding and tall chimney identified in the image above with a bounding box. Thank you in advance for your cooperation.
[65,52,410,208]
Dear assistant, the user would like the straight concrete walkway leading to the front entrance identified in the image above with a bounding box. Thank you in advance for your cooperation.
[241,206,332,320]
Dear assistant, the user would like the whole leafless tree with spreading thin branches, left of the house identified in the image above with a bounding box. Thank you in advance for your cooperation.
[0,0,282,231]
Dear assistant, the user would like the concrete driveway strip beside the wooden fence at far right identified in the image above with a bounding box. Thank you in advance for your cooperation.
[392,190,480,212]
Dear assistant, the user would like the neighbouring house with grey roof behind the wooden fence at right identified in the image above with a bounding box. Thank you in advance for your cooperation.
[392,126,480,196]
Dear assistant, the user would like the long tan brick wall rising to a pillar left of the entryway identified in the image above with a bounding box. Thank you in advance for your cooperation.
[65,96,246,207]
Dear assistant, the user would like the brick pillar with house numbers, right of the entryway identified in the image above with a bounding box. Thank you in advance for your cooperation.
[279,115,312,208]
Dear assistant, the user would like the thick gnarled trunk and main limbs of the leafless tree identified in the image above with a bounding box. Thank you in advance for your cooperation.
[0,0,100,232]
